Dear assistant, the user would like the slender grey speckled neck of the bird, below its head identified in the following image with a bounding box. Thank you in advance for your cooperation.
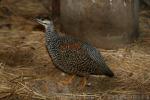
[45,26,58,42]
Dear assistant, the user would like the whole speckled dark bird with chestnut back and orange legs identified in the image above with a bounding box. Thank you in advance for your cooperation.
[36,18,114,87]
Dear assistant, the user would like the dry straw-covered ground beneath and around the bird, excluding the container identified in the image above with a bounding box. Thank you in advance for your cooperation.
[0,6,150,100]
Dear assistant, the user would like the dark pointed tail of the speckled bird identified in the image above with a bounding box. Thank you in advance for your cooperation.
[100,63,114,77]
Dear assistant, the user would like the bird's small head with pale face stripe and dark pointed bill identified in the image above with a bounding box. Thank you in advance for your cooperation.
[36,18,53,28]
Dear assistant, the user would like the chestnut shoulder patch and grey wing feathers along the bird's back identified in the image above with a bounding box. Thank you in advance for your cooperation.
[57,36,104,64]
